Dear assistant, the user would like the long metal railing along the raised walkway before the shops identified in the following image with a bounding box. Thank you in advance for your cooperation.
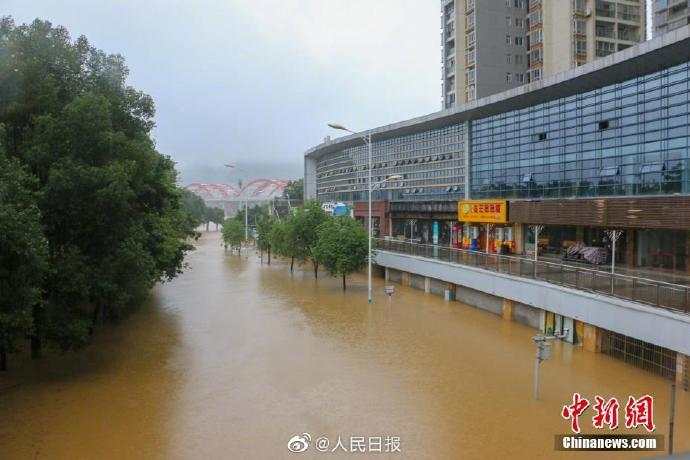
[375,239,690,314]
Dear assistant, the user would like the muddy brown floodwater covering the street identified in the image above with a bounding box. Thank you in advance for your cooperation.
[0,233,690,459]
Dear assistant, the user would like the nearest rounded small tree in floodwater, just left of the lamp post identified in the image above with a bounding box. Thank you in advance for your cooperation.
[314,217,368,290]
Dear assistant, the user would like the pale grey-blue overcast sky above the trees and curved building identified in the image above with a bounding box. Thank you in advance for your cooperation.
[0,0,441,180]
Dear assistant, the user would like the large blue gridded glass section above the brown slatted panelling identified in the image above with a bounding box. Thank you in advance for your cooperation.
[470,63,690,198]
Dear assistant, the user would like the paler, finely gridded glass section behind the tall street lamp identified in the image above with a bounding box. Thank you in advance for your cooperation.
[316,123,466,201]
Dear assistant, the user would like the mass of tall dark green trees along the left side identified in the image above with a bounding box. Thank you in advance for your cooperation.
[0,17,200,369]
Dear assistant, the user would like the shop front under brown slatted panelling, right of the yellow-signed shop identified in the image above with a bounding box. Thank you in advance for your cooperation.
[509,196,690,281]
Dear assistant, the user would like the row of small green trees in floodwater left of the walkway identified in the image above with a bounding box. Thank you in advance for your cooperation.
[223,201,368,289]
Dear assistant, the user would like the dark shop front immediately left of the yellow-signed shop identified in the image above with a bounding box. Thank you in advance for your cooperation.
[390,201,460,247]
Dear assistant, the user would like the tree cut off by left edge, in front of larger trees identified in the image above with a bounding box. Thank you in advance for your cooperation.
[0,143,48,371]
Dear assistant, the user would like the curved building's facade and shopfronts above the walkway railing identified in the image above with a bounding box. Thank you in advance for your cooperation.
[305,27,690,280]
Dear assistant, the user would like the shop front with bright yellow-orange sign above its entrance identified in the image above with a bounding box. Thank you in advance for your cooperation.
[458,200,515,254]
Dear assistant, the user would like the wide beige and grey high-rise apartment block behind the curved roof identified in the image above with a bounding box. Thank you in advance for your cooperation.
[441,0,644,108]
